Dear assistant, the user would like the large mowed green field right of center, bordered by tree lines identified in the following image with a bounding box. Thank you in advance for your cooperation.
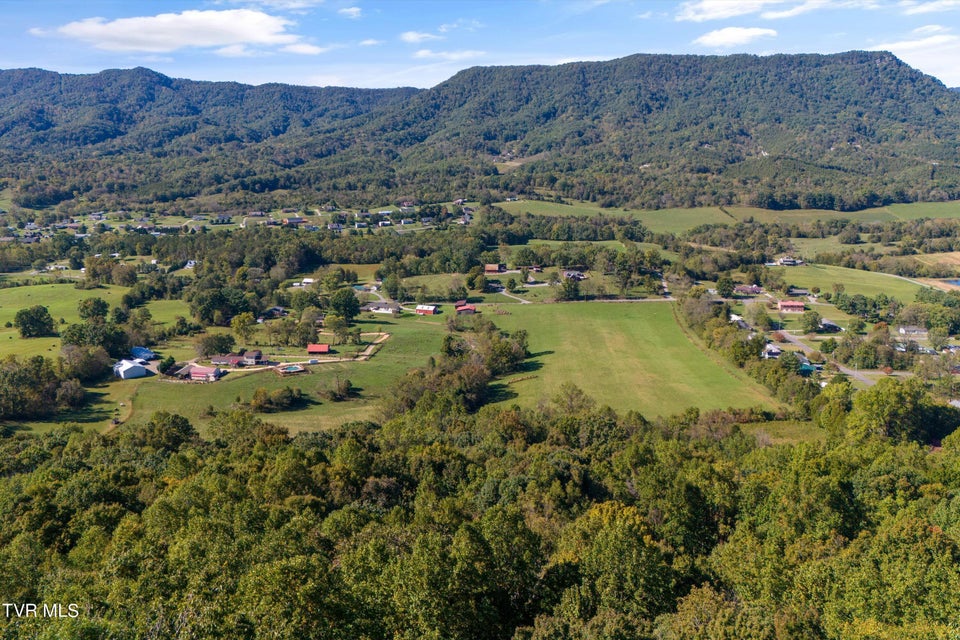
[484,302,777,417]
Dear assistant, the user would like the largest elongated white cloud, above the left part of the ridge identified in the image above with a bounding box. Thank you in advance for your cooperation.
[37,9,300,55]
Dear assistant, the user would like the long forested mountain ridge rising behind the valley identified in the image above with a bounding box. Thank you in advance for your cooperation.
[0,52,960,212]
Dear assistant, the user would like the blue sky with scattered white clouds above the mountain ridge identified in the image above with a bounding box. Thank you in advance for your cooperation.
[0,0,960,87]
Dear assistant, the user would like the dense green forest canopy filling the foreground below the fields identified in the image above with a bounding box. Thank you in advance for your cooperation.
[0,336,960,640]
